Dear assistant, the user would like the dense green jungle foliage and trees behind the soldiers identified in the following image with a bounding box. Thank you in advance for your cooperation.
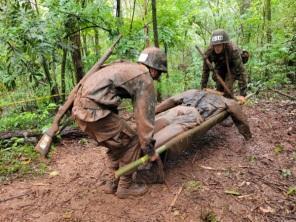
[0,0,296,154]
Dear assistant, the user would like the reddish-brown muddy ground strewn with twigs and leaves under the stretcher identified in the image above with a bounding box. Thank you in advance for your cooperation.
[0,99,296,222]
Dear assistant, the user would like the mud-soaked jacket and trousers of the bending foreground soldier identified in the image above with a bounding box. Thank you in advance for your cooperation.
[72,62,156,187]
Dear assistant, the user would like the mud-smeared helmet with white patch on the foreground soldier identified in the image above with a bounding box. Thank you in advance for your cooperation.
[138,47,167,72]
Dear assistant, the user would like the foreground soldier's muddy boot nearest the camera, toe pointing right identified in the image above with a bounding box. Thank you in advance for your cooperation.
[116,175,148,199]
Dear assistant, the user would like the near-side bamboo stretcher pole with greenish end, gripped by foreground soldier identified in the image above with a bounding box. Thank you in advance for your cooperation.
[115,110,229,178]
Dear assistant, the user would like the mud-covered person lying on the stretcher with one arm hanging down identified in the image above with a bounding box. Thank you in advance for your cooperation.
[134,89,252,183]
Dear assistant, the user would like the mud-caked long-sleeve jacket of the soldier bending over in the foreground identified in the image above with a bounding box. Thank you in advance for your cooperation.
[72,62,156,147]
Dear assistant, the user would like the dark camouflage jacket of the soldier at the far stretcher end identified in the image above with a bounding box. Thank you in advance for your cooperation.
[201,43,247,96]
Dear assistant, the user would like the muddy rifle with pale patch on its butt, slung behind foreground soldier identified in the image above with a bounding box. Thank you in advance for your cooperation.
[35,35,122,156]
